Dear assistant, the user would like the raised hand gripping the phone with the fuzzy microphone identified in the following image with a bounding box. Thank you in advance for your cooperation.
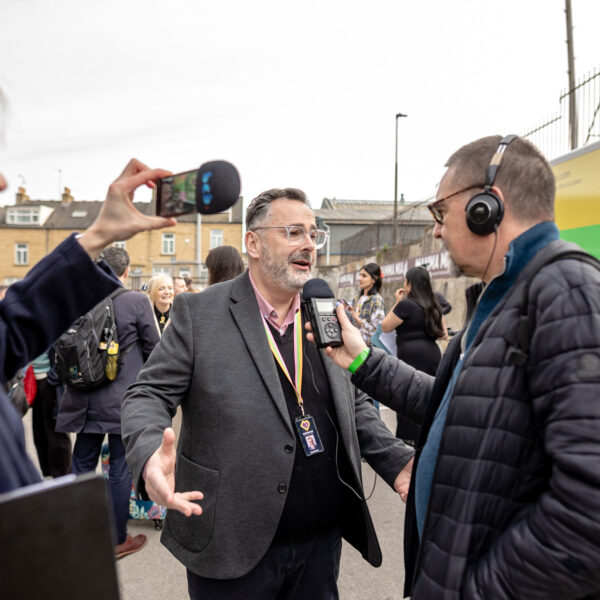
[79,158,176,259]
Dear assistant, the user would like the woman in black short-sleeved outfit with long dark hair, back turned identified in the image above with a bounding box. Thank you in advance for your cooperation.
[381,267,446,444]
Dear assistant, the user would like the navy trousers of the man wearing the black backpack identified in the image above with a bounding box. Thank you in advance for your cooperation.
[73,432,131,544]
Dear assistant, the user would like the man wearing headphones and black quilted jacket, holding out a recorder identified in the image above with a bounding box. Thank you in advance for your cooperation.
[314,136,600,600]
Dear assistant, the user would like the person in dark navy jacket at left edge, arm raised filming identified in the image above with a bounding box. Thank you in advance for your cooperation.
[0,160,175,496]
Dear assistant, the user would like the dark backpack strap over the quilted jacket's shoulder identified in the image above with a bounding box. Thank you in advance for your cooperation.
[504,240,600,367]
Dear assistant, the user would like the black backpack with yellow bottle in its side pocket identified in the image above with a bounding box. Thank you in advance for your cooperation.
[54,288,129,390]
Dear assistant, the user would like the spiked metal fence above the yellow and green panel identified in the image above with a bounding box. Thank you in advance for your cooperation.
[521,68,600,160]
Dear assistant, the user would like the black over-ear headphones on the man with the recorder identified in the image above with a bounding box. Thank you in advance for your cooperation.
[465,135,517,235]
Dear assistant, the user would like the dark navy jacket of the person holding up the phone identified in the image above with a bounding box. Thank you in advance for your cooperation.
[0,235,119,493]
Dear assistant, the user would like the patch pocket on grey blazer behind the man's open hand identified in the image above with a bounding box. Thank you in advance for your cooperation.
[168,454,220,552]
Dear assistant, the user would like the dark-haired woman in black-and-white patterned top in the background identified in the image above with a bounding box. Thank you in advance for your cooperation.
[350,263,385,344]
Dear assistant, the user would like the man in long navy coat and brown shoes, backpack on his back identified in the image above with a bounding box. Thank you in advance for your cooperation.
[56,246,160,558]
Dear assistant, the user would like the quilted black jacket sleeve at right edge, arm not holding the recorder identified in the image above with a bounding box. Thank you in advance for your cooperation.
[462,260,600,599]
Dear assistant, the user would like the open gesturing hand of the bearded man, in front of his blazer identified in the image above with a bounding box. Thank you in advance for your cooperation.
[145,427,204,517]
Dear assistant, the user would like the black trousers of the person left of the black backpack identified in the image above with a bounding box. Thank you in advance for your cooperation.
[31,379,71,477]
